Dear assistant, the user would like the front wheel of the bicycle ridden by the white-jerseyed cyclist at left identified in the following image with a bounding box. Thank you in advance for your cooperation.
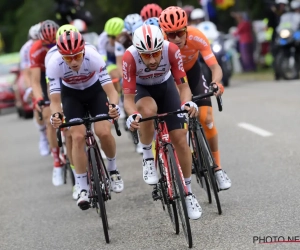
[89,148,110,243]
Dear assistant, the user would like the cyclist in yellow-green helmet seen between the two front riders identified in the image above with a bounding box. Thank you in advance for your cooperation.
[98,17,125,118]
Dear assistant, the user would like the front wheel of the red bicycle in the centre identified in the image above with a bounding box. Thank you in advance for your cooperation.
[166,144,193,248]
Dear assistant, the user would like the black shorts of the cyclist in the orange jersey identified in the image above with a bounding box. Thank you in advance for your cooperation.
[186,60,211,107]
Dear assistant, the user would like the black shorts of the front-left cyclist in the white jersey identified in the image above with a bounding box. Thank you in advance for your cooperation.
[61,81,108,122]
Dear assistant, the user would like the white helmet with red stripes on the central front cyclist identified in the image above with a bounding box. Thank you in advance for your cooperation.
[132,25,164,53]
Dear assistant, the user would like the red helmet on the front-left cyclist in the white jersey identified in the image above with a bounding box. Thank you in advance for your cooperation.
[56,30,85,55]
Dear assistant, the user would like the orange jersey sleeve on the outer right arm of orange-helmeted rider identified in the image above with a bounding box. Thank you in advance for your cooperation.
[193,28,218,66]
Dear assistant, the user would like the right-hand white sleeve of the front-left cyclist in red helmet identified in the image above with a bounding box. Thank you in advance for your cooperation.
[90,51,112,86]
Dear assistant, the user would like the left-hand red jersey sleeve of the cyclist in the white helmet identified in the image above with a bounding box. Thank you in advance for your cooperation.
[122,50,136,94]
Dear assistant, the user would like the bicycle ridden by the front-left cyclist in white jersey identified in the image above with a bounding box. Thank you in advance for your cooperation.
[57,108,121,243]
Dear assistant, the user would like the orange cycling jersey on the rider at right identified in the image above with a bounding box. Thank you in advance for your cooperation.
[180,26,218,71]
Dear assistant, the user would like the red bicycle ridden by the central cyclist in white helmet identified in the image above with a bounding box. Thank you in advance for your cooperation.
[133,110,193,248]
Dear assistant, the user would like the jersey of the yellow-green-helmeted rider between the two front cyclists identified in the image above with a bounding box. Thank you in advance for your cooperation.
[98,31,125,63]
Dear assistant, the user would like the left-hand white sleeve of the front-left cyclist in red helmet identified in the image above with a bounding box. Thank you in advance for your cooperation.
[46,58,61,95]
